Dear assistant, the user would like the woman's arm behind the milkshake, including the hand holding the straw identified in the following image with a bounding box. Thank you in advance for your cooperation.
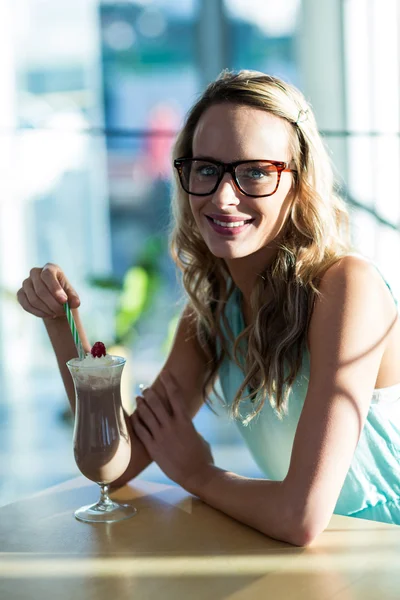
[17,263,205,487]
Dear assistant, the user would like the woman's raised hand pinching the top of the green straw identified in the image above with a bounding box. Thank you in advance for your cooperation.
[17,263,80,319]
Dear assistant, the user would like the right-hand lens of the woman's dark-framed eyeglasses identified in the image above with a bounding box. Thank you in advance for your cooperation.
[236,160,278,196]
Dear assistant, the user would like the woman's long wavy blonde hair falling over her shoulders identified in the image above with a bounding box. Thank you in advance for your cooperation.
[170,71,351,422]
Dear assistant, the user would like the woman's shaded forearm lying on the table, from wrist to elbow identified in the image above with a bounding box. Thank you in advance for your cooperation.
[189,466,297,544]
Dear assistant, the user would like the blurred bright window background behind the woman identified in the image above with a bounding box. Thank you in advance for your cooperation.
[0,0,400,505]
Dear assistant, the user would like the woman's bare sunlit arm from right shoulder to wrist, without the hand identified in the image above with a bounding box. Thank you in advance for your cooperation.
[180,257,397,546]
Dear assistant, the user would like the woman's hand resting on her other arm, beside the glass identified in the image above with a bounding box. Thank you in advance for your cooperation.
[130,371,214,494]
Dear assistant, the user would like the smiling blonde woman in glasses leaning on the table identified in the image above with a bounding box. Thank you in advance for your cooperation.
[18,71,400,546]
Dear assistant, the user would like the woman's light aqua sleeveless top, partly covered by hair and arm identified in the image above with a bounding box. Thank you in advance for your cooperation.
[219,268,400,525]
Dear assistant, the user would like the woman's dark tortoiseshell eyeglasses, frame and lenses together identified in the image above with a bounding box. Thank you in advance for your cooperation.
[174,158,296,198]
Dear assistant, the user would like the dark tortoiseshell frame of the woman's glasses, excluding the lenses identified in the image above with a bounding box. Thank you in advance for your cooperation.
[174,156,297,198]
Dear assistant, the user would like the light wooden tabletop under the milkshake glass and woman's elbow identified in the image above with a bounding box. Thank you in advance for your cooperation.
[0,477,400,600]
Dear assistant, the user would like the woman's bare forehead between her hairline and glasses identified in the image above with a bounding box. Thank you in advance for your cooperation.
[192,103,291,162]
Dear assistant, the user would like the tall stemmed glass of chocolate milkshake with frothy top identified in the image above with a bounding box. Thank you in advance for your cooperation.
[67,355,136,523]
